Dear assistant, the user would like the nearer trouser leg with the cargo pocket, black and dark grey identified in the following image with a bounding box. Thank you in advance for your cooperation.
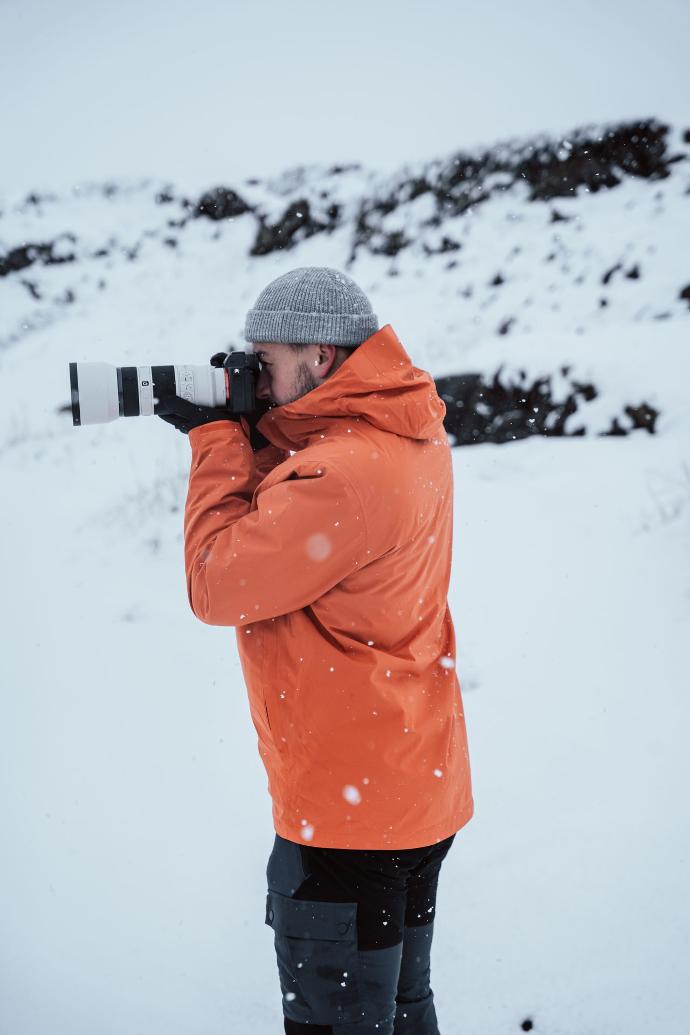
[266,837,408,1035]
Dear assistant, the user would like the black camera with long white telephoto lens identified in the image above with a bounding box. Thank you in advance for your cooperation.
[69,352,261,427]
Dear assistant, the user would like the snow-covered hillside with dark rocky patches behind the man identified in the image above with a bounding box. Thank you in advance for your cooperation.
[0,120,690,1035]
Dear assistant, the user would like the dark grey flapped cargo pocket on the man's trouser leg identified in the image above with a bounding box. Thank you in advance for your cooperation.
[266,891,360,1025]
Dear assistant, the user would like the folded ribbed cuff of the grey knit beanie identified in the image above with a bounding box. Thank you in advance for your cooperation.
[244,309,379,347]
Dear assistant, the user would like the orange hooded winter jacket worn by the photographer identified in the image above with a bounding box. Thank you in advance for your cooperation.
[184,325,473,849]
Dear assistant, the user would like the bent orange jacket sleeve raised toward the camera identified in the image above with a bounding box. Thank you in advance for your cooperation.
[184,421,366,626]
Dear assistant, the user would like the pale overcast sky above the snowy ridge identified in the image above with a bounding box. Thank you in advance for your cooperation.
[0,0,690,191]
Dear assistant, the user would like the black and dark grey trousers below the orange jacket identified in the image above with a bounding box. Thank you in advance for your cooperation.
[266,834,455,1035]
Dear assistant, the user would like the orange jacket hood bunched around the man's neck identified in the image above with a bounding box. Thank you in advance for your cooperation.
[258,324,446,450]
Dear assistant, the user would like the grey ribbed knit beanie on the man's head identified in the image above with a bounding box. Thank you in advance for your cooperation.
[244,266,379,348]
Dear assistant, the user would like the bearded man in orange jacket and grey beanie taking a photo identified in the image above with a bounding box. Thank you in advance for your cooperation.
[163,267,473,1035]
